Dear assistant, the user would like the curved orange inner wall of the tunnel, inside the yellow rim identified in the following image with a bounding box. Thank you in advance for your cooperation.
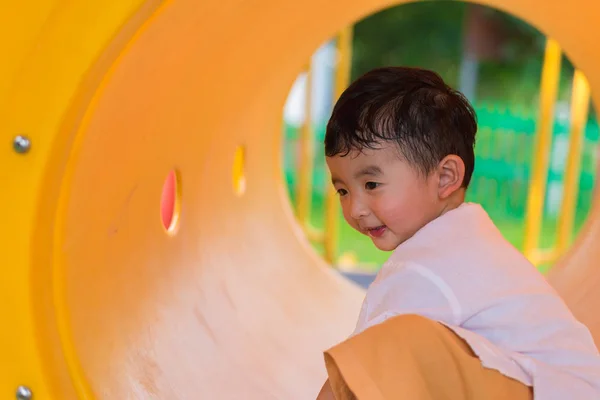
[3,0,600,399]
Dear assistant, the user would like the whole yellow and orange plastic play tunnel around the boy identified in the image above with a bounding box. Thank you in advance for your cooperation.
[0,0,600,400]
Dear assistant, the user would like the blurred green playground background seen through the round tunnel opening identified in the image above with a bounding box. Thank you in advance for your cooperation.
[282,1,599,280]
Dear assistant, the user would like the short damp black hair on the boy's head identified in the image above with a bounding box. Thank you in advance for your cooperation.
[325,67,477,188]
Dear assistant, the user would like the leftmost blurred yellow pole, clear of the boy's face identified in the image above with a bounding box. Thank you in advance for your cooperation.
[296,64,314,228]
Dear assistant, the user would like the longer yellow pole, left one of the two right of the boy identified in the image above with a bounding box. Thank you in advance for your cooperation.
[523,38,561,263]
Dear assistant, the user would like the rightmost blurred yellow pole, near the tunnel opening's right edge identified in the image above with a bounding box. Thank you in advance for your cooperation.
[556,70,590,254]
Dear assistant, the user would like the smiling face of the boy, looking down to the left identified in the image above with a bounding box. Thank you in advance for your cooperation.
[327,143,441,251]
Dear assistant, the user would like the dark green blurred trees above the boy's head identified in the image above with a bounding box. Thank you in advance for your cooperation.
[352,1,573,111]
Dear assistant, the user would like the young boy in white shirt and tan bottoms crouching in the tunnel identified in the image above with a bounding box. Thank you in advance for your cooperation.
[318,67,600,400]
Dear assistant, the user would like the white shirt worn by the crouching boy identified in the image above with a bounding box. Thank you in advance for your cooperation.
[353,203,600,400]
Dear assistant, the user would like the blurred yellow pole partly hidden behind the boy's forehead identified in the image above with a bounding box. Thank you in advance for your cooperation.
[324,26,352,265]
